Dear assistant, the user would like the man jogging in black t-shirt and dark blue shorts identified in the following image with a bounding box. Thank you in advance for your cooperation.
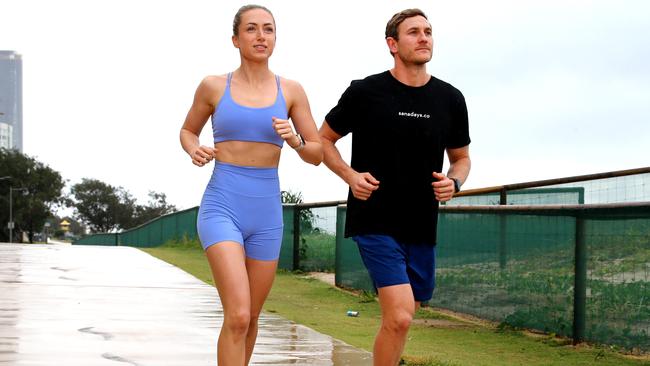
[320,9,471,365]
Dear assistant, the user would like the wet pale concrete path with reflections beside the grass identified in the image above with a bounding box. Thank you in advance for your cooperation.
[0,244,372,366]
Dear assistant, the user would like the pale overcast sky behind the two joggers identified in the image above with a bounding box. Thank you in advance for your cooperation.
[0,0,650,209]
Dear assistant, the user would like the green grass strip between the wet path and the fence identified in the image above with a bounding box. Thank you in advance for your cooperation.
[143,244,650,366]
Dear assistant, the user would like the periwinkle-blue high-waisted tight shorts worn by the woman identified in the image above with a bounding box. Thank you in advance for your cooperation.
[196,162,283,260]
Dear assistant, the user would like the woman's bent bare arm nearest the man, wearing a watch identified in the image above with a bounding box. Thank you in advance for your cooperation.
[274,79,323,165]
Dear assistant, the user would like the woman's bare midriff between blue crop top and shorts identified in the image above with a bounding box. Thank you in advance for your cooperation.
[214,141,281,168]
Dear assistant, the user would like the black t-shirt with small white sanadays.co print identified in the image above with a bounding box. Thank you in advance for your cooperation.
[325,71,470,245]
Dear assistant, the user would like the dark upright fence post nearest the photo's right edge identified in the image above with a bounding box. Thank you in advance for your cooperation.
[573,214,587,344]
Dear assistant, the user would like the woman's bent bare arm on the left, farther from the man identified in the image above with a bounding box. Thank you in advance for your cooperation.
[180,76,223,166]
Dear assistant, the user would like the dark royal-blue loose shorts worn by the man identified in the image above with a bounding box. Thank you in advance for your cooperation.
[352,235,436,301]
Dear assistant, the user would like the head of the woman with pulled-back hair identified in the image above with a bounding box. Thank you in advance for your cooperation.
[232,9,275,60]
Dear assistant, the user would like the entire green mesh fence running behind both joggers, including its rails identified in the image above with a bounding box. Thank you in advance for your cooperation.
[75,168,650,351]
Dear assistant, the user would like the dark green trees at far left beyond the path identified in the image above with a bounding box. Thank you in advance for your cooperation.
[0,148,176,242]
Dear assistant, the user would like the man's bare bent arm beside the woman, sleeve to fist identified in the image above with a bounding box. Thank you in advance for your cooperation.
[318,121,379,201]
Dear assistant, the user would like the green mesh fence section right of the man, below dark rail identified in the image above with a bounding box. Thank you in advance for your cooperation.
[430,203,650,350]
